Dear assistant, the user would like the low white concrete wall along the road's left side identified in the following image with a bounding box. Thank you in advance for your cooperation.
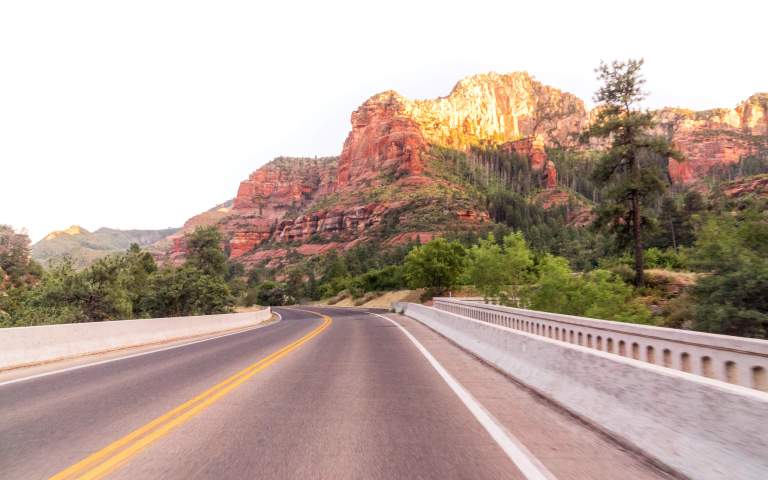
[0,308,272,369]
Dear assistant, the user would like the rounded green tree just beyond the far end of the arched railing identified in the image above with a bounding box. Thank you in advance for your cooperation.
[405,238,466,295]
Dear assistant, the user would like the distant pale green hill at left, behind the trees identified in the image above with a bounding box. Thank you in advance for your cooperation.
[32,225,179,268]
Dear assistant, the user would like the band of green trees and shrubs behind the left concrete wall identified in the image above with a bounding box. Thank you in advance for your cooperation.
[0,228,234,326]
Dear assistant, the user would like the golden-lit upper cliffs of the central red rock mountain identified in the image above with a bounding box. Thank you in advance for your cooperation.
[337,72,587,190]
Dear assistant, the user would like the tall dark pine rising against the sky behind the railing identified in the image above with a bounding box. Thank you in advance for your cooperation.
[585,60,681,286]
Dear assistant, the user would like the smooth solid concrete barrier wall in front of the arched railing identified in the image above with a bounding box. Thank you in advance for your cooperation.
[395,303,768,480]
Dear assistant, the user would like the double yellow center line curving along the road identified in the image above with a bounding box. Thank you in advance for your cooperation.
[51,310,333,480]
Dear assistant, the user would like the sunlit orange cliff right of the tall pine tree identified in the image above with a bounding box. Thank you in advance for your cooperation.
[656,93,768,183]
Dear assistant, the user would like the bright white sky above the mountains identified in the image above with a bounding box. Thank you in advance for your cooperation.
[0,0,768,240]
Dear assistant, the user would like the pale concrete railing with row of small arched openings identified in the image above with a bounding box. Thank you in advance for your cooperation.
[434,297,768,391]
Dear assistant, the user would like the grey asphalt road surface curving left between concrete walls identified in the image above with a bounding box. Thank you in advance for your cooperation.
[0,307,663,480]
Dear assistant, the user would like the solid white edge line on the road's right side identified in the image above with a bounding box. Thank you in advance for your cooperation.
[371,313,556,480]
